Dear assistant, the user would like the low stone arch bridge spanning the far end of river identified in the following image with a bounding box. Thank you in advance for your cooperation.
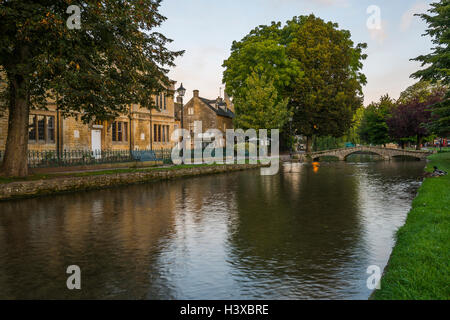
[299,146,433,161]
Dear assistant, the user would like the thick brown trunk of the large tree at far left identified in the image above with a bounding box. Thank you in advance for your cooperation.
[1,76,30,177]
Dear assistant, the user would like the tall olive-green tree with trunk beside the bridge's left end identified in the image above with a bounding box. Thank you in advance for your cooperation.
[287,15,366,152]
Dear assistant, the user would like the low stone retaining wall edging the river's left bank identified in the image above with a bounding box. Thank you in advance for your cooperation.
[0,164,266,201]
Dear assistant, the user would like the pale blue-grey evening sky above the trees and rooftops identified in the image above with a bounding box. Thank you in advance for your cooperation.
[158,0,432,105]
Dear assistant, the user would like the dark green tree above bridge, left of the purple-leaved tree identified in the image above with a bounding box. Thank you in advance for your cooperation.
[359,94,395,145]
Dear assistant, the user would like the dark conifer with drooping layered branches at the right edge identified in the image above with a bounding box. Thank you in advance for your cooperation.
[412,0,450,136]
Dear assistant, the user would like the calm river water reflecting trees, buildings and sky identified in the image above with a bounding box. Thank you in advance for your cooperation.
[0,161,425,299]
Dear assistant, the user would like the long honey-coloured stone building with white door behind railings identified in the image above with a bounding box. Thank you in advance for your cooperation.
[0,85,176,151]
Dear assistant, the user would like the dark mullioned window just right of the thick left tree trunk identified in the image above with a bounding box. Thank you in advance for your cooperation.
[28,115,55,143]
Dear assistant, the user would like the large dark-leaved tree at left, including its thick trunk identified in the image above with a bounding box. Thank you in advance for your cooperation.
[0,0,182,176]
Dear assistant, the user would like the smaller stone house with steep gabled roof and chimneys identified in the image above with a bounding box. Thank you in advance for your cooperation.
[177,90,234,146]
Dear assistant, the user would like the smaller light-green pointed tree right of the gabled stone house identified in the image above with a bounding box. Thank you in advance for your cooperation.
[233,72,290,130]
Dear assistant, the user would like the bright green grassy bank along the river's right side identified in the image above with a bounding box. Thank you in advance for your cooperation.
[372,152,450,300]
